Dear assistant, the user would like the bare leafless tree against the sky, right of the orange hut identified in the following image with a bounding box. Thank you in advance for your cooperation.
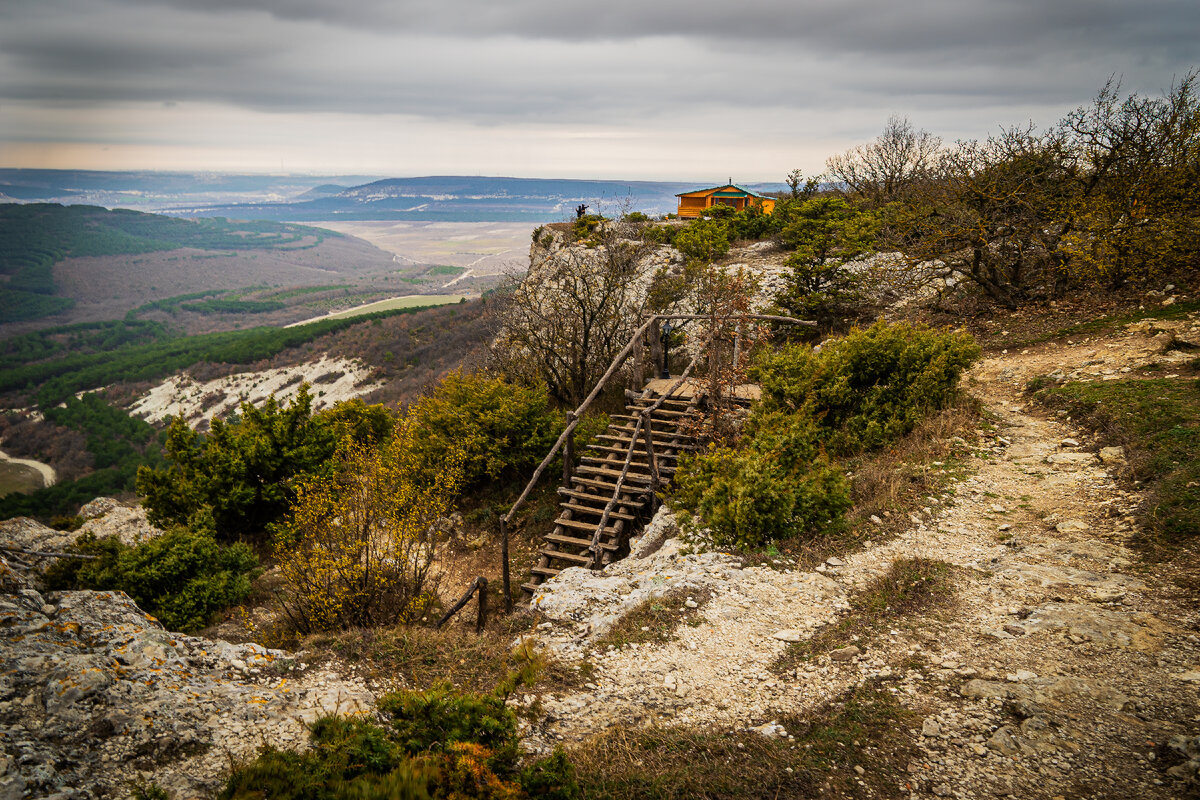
[826,116,942,205]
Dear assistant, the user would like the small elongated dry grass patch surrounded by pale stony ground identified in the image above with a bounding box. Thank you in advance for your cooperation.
[772,558,954,674]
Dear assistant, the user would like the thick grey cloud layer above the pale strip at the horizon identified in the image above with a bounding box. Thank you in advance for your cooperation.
[0,0,1200,154]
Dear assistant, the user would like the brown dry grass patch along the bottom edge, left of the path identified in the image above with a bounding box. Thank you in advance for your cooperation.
[570,684,916,800]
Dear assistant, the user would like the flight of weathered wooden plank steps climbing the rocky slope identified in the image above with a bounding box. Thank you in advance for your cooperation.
[521,383,701,593]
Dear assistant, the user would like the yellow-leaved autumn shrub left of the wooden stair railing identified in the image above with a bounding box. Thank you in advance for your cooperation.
[275,420,463,633]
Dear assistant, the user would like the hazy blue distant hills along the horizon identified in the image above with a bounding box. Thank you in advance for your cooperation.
[0,169,785,222]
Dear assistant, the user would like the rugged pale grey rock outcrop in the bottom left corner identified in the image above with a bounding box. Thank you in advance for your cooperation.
[0,498,374,800]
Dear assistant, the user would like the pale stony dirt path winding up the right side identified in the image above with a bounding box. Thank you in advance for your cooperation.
[525,331,1200,799]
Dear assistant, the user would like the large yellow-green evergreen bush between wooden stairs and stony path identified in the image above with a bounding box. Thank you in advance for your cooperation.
[672,321,979,548]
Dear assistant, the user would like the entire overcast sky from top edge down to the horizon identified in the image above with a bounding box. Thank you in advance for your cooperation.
[0,0,1200,182]
